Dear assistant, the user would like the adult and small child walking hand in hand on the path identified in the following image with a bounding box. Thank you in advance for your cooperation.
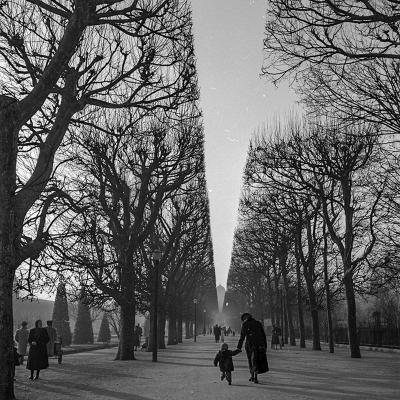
[214,313,269,385]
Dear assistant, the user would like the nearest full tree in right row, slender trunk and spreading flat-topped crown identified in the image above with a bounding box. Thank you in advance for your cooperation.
[253,118,385,357]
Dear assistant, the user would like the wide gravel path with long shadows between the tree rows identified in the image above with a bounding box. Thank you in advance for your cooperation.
[16,336,400,400]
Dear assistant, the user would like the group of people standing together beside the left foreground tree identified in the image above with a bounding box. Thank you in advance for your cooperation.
[14,320,57,380]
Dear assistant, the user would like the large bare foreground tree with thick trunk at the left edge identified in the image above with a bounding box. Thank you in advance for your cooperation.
[0,0,196,399]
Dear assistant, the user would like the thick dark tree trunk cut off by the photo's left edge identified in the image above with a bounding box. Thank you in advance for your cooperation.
[0,96,18,400]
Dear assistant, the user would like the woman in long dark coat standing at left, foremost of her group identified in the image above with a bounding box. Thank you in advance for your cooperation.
[26,319,50,379]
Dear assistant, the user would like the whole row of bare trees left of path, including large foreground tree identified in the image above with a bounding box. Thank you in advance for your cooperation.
[0,0,216,399]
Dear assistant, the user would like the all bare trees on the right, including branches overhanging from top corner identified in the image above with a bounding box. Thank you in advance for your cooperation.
[229,0,400,357]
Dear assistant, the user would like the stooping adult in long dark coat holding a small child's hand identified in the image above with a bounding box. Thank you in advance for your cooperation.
[237,313,269,383]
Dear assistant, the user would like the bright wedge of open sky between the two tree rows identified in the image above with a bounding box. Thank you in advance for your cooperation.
[192,0,295,287]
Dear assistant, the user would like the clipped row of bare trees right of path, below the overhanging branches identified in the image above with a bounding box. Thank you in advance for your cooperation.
[229,121,399,357]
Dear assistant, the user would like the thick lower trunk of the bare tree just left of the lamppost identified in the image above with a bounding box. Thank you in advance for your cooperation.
[116,302,135,361]
